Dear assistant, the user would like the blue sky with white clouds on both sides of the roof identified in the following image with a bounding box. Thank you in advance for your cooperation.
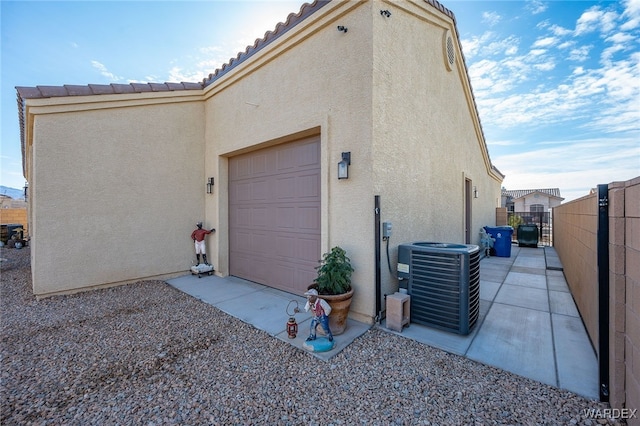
[0,0,640,201]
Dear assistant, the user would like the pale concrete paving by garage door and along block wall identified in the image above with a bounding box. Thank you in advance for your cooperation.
[168,246,599,399]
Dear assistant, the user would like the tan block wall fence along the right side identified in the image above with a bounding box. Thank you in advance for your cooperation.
[553,177,640,425]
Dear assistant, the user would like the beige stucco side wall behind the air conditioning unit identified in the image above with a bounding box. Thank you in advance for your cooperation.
[373,1,500,293]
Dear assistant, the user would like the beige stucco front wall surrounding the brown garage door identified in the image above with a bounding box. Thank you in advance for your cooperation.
[205,2,375,318]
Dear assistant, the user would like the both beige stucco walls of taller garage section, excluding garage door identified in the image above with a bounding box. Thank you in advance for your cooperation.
[198,1,501,320]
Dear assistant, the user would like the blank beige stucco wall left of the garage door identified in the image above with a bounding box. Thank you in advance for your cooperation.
[29,95,205,295]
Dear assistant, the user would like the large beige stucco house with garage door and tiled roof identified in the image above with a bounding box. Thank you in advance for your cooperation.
[17,0,504,323]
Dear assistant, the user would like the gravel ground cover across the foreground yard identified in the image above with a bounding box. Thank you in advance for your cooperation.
[0,248,618,425]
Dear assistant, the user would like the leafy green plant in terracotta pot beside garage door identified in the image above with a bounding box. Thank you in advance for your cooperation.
[309,246,353,335]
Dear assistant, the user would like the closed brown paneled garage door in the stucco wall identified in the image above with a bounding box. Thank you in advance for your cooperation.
[229,137,320,294]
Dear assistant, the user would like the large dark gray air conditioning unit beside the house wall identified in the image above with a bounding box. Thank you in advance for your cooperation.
[398,242,480,335]
